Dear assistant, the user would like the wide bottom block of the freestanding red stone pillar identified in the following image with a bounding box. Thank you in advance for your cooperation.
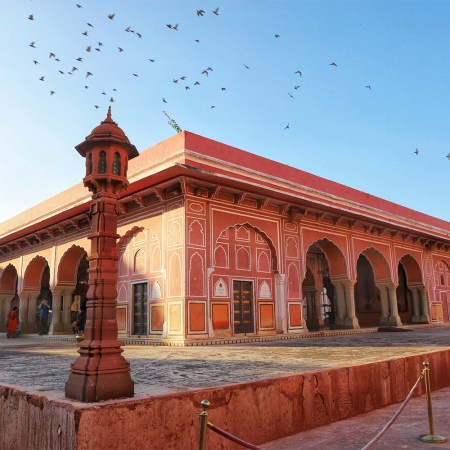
[65,372,134,403]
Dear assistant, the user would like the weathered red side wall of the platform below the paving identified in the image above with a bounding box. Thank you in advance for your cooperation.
[0,350,450,450]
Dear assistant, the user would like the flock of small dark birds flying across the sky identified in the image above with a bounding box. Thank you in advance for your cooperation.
[23,4,450,160]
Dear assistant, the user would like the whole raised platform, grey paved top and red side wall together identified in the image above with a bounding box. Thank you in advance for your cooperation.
[0,327,450,450]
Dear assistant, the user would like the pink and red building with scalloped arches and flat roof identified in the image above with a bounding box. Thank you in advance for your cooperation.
[0,114,450,344]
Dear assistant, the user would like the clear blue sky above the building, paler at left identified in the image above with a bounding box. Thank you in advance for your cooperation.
[0,0,450,222]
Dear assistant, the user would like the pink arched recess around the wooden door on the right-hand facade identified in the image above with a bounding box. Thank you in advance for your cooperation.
[212,223,278,336]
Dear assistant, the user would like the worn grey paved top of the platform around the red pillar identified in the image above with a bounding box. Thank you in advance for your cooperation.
[0,326,450,395]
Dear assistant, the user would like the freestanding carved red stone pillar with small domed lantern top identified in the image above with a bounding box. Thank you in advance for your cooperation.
[65,108,135,403]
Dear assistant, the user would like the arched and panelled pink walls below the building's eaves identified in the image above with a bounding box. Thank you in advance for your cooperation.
[0,211,450,339]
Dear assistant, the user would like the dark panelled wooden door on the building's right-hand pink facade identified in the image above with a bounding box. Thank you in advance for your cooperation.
[233,280,254,334]
